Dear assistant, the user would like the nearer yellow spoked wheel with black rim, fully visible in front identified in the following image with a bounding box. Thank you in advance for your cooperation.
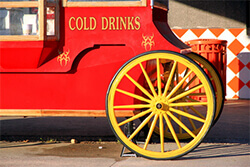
[106,51,216,159]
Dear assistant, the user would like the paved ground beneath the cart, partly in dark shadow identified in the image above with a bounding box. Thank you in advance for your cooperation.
[0,100,250,167]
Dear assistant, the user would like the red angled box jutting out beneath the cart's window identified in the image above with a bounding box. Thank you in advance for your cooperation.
[0,41,58,72]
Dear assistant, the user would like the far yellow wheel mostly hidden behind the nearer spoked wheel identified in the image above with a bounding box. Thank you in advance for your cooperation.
[148,53,225,140]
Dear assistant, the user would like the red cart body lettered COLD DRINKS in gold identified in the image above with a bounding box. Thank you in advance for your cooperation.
[0,1,188,115]
